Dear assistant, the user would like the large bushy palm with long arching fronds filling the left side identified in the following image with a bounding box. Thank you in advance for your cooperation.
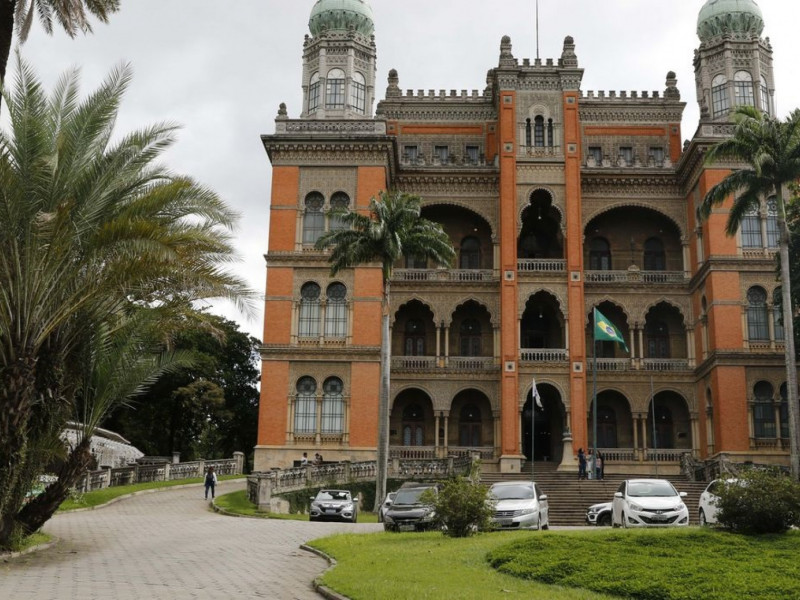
[0,60,254,545]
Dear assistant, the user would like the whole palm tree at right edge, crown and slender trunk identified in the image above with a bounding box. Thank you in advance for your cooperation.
[698,106,800,480]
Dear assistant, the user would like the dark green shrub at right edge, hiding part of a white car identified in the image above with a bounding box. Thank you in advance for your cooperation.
[717,469,800,534]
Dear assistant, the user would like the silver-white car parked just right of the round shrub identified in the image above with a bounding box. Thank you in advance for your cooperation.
[489,481,550,529]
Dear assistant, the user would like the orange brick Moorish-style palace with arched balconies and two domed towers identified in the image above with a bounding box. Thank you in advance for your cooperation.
[255,0,788,473]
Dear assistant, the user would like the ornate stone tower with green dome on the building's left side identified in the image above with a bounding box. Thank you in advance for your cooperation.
[301,0,376,119]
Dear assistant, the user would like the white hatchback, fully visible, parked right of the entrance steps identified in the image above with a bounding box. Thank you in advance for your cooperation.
[611,479,689,527]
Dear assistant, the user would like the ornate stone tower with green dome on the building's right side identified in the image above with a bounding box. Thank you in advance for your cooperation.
[694,0,775,121]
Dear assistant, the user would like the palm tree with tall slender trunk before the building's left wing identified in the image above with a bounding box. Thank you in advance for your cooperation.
[317,192,455,512]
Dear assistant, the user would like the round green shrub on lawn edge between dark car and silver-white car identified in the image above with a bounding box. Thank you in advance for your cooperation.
[423,463,494,537]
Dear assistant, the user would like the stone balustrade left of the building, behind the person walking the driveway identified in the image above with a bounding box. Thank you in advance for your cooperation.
[80,452,244,492]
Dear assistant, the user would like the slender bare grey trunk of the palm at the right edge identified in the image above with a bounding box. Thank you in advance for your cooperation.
[776,186,800,481]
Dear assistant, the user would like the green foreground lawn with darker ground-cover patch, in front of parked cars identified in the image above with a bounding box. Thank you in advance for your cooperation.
[311,528,800,600]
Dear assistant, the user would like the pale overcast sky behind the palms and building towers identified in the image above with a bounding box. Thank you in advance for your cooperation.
[9,0,800,339]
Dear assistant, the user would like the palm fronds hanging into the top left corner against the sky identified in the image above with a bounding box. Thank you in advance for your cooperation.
[0,0,121,95]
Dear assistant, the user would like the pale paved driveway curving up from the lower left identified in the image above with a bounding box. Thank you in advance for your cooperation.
[0,481,381,600]
